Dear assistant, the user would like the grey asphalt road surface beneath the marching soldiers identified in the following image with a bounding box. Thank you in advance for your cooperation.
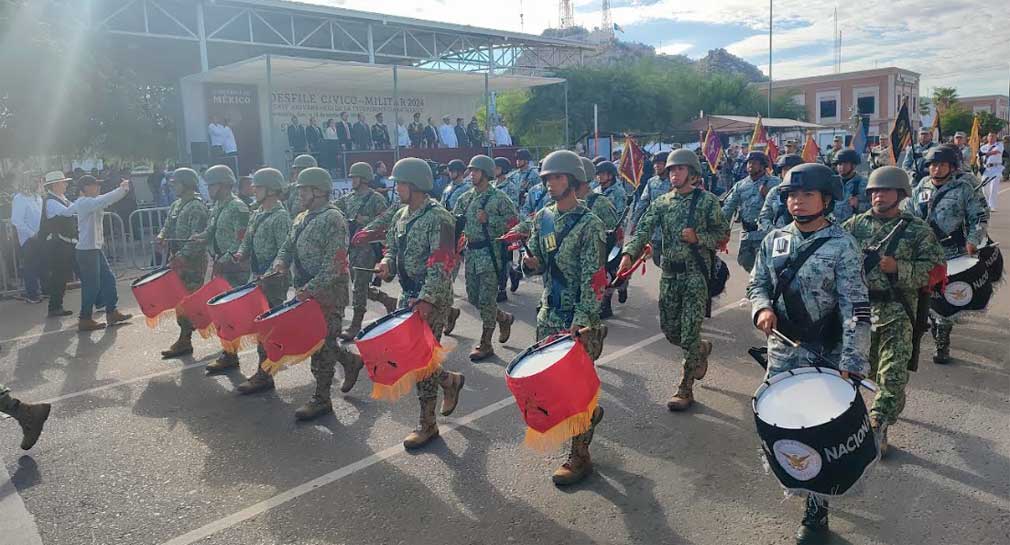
[0,186,1010,545]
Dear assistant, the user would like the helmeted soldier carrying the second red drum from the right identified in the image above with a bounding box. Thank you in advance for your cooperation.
[379,157,464,449]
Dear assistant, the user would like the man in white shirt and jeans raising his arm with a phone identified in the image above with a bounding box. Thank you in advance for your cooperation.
[60,176,132,331]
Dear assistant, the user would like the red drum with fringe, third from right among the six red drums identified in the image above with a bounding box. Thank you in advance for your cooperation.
[255,299,326,374]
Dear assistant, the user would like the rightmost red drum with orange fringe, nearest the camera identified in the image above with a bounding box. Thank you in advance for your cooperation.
[505,335,600,451]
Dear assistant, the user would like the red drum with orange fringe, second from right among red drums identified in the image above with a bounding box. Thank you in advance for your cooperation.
[355,309,445,401]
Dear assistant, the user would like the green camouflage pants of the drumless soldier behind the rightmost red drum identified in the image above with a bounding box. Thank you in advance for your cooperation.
[660,273,708,373]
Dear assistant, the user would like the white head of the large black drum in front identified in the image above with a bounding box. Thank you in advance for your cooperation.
[754,367,856,430]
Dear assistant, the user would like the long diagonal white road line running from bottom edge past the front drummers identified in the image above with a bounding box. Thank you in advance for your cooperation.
[155,299,746,545]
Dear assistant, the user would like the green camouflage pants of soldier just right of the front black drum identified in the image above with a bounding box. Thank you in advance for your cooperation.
[870,319,912,424]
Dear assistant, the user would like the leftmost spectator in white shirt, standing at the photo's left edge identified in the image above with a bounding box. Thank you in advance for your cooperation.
[10,173,42,305]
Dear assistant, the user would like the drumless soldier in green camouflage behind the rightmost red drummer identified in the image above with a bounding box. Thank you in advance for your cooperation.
[618,149,729,411]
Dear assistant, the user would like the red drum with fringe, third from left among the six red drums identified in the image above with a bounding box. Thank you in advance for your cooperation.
[207,283,270,354]
